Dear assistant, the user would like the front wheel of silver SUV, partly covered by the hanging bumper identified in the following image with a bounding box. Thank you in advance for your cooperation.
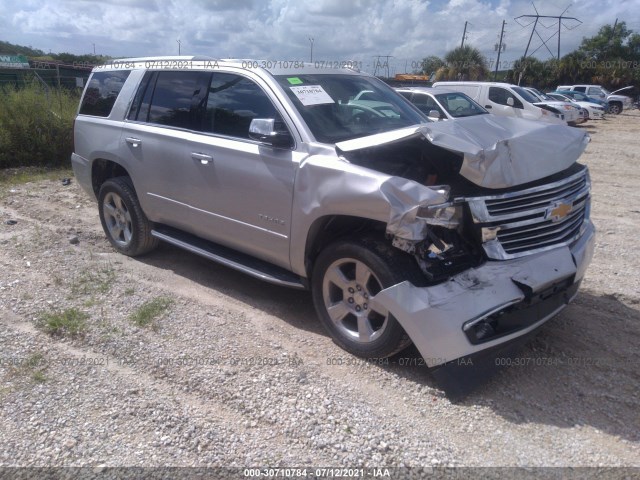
[311,239,425,358]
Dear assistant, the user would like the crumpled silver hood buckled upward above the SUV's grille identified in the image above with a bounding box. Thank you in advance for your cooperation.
[336,115,590,189]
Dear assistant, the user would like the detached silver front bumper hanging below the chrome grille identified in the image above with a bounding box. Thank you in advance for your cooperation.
[373,222,595,367]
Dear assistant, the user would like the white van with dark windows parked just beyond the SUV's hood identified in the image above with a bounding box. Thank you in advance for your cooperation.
[433,82,567,125]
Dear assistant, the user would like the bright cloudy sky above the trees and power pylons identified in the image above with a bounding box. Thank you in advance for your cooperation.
[0,0,640,75]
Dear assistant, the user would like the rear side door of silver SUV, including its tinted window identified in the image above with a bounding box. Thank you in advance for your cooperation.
[120,70,211,231]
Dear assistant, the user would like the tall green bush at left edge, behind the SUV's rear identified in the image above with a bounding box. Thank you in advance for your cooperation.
[0,81,78,168]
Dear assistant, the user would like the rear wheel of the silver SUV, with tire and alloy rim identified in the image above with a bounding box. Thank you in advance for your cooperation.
[98,177,158,257]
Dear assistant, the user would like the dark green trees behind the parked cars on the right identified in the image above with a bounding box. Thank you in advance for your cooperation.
[416,22,640,89]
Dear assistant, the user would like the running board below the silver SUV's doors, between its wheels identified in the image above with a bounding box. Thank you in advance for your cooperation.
[151,225,306,289]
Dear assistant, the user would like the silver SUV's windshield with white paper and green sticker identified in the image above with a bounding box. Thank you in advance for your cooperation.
[275,74,428,143]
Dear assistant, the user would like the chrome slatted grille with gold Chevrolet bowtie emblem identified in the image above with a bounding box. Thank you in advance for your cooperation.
[465,167,591,259]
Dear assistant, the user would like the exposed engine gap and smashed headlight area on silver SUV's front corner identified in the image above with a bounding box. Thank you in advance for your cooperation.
[342,135,483,284]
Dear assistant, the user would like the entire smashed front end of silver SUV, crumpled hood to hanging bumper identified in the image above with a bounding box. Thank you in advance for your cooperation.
[338,119,595,367]
